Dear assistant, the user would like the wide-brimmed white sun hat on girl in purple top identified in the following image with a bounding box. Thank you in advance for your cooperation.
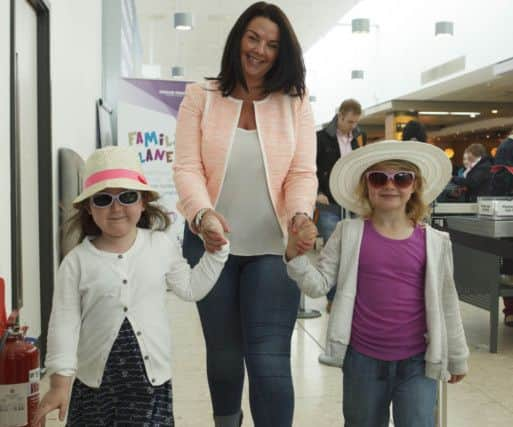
[330,140,452,215]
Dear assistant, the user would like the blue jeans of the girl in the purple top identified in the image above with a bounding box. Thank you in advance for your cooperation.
[342,346,437,427]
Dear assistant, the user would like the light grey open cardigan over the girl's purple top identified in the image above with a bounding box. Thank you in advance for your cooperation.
[287,219,469,381]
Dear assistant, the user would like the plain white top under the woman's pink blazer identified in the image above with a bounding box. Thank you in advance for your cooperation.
[216,128,285,256]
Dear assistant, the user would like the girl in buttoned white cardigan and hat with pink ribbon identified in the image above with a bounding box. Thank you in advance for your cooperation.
[38,147,229,426]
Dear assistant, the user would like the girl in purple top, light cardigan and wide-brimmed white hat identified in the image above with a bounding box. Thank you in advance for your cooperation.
[286,141,469,427]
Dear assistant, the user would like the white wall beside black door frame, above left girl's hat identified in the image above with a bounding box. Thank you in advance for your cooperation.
[51,0,102,272]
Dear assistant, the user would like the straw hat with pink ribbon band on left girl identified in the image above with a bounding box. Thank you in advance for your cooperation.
[73,146,159,207]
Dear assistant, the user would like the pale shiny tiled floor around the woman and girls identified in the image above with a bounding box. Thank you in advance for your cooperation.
[43,297,513,427]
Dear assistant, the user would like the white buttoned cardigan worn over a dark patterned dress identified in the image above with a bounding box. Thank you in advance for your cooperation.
[45,229,229,387]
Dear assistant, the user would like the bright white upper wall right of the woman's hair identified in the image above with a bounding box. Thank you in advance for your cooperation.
[305,0,513,123]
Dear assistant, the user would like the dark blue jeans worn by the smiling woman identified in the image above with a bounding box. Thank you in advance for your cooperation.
[183,226,299,427]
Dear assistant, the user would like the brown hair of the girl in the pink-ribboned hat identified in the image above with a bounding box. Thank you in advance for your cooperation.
[63,191,171,243]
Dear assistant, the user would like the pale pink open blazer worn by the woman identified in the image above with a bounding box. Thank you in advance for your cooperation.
[173,82,317,235]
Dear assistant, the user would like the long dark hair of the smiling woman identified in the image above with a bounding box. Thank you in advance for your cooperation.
[210,1,305,98]
